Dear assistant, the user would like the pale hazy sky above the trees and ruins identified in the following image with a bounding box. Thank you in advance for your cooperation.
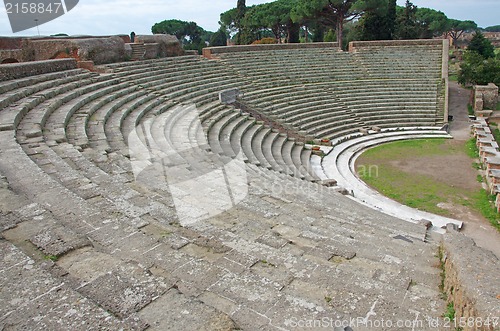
[0,0,500,36]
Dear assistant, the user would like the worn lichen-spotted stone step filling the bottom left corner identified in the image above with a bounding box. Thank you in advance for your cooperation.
[0,240,146,330]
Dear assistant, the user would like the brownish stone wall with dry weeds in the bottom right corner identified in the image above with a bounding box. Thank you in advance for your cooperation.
[442,226,500,331]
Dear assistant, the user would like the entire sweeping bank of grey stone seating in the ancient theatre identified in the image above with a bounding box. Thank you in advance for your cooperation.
[0,40,500,331]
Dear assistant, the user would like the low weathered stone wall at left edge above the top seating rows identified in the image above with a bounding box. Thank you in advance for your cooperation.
[0,59,77,81]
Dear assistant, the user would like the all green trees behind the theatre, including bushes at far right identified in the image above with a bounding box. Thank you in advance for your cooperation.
[151,0,500,85]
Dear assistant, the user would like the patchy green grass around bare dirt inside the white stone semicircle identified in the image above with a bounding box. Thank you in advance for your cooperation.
[358,139,500,231]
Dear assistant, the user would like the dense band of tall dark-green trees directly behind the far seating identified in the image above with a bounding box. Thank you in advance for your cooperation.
[219,0,477,45]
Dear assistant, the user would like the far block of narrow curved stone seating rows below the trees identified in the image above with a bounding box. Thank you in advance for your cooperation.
[214,42,445,139]
